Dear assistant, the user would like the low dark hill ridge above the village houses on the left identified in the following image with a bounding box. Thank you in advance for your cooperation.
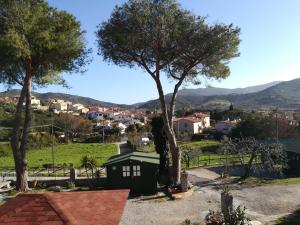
[0,89,131,108]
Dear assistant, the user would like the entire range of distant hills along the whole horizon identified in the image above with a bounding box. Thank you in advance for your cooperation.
[1,78,300,110]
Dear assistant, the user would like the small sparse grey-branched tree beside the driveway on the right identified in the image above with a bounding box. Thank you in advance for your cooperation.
[222,138,286,179]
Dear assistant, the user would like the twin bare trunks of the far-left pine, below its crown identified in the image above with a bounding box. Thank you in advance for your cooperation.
[11,73,32,192]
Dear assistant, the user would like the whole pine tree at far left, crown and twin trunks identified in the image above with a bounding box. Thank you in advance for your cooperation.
[0,0,88,191]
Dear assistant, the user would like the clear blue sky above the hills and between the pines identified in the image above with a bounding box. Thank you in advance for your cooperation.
[0,0,300,104]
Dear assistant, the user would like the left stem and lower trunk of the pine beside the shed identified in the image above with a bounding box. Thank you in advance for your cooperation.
[156,79,181,185]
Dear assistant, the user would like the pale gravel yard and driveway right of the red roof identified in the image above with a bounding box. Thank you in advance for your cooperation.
[121,169,300,225]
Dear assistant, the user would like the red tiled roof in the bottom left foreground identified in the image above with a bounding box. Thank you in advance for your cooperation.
[0,190,129,225]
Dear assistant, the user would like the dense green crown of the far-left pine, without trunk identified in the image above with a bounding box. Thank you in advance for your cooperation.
[0,0,88,85]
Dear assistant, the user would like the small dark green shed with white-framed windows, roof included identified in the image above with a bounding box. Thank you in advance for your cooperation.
[104,152,159,194]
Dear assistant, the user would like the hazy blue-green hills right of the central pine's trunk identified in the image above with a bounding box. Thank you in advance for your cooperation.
[139,79,300,110]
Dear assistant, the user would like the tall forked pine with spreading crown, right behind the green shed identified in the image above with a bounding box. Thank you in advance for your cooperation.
[97,0,240,184]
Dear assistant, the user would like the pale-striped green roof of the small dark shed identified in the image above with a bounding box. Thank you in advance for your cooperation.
[104,152,159,166]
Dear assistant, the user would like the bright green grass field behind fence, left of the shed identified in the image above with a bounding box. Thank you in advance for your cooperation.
[0,143,117,168]
